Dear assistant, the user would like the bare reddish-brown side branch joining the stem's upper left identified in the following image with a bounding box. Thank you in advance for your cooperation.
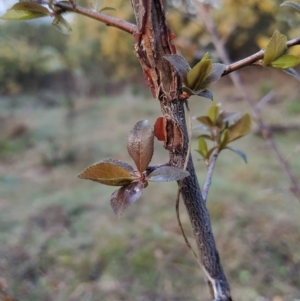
[55,1,137,34]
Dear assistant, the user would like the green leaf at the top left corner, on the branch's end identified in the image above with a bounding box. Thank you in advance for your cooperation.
[0,2,51,21]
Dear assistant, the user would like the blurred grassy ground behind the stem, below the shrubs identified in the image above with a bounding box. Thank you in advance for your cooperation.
[0,71,300,301]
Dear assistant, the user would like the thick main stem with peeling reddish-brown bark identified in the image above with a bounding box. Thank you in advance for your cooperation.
[131,0,232,301]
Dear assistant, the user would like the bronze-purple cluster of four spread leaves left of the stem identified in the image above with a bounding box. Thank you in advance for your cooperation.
[78,120,189,216]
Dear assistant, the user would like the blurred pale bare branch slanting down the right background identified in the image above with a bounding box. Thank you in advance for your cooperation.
[195,2,300,201]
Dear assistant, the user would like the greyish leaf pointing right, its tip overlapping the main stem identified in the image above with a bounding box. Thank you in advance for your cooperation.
[147,166,190,182]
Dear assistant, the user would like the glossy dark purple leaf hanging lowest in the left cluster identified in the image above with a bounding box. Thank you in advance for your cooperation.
[110,181,144,217]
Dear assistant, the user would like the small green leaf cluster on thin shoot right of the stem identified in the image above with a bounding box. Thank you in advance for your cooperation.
[196,102,251,163]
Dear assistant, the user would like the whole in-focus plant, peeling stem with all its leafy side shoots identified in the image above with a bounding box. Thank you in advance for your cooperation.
[2,0,300,301]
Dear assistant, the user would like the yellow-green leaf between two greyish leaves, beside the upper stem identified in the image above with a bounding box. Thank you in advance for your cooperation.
[184,53,212,92]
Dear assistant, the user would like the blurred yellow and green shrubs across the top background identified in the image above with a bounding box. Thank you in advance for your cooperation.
[0,0,299,94]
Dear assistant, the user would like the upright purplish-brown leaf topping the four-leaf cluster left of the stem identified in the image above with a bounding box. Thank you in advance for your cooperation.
[127,120,154,173]
